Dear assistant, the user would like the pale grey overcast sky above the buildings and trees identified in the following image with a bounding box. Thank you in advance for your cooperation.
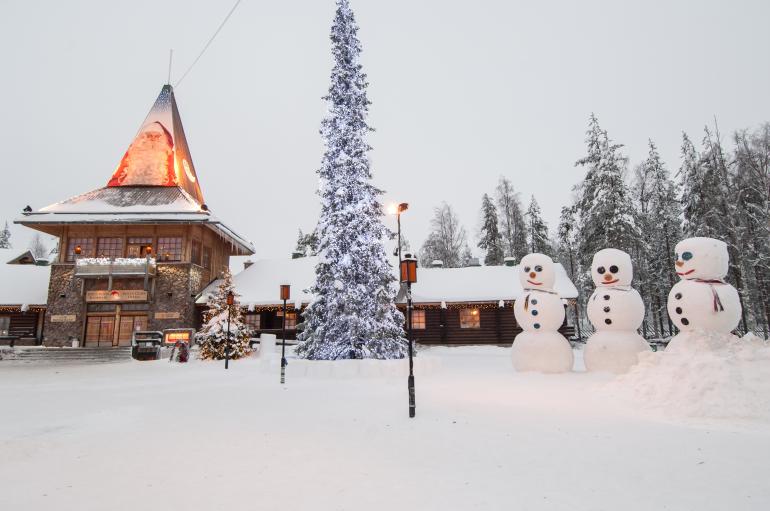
[0,0,770,257]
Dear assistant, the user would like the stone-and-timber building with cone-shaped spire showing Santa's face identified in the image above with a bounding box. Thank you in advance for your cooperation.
[16,85,253,347]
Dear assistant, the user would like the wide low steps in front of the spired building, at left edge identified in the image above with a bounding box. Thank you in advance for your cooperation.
[0,346,131,364]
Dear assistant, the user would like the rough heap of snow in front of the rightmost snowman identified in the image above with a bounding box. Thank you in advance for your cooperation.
[610,331,770,422]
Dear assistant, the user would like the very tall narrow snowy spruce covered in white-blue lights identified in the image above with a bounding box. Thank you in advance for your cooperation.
[296,0,406,360]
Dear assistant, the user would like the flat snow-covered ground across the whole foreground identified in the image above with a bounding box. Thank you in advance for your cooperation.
[0,347,770,511]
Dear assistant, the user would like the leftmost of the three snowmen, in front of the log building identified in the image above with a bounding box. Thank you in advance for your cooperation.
[511,254,573,373]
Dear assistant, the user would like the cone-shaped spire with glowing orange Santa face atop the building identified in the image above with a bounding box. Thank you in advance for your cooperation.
[107,85,203,204]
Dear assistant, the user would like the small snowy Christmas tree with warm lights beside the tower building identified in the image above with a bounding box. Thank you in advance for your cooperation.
[198,269,251,360]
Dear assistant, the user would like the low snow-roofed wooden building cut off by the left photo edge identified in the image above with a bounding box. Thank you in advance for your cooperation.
[0,249,50,346]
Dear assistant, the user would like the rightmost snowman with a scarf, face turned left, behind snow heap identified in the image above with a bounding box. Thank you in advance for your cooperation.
[667,238,742,351]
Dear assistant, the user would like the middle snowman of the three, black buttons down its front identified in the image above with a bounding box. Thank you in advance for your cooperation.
[583,248,651,373]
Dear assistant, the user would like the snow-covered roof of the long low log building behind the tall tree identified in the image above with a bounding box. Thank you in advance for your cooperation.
[197,257,578,307]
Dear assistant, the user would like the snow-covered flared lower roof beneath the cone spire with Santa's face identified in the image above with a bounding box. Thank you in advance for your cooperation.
[15,186,254,254]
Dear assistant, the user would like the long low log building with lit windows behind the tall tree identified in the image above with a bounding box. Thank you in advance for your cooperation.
[197,257,577,345]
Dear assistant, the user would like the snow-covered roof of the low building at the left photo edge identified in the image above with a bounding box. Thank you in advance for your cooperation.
[0,248,51,306]
